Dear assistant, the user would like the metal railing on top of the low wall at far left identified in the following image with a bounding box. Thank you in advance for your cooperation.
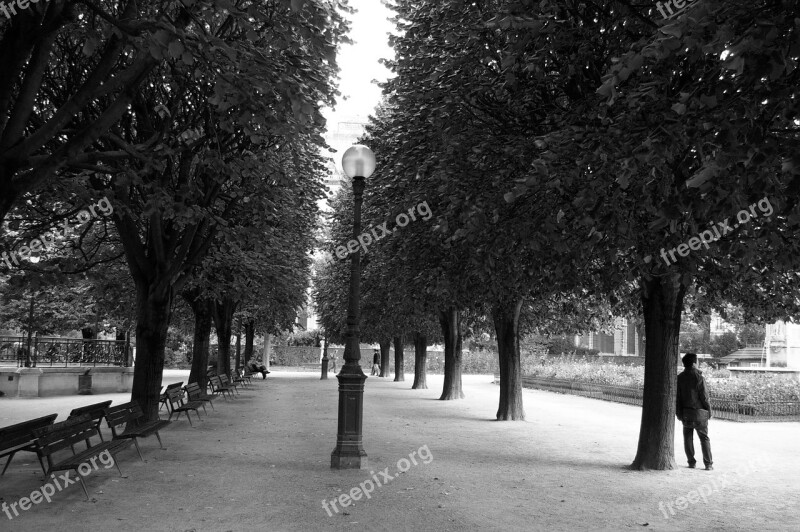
[0,336,131,367]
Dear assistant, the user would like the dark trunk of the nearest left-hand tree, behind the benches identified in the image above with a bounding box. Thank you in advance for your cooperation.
[131,281,173,420]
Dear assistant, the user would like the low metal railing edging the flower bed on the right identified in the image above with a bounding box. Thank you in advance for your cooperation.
[495,374,800,421]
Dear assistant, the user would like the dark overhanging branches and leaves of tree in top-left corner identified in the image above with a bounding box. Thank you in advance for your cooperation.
[0,0,220,221]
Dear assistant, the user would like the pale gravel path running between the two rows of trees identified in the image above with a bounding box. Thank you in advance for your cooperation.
[0,368,800,532]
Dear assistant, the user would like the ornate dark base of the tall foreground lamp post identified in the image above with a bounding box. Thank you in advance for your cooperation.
[331,364,368,469]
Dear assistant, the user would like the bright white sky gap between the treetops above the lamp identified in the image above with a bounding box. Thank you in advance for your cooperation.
[324,0,394,131]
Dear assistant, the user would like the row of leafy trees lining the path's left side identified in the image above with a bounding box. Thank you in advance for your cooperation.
[0,0,349,417]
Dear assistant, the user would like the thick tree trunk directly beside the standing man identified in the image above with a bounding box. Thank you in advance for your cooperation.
[631,277,686,470]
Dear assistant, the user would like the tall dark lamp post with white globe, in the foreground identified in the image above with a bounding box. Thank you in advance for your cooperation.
[331,144,375,469]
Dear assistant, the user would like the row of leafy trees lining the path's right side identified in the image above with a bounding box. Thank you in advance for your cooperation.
[317,0,800,469]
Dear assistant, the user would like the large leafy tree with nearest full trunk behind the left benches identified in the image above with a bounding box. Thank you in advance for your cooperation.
[83,1,346,417]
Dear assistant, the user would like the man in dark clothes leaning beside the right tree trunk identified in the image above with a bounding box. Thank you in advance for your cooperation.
[675,353,714,471]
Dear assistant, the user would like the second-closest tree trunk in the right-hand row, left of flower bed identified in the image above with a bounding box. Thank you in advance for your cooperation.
[492,299,525,421]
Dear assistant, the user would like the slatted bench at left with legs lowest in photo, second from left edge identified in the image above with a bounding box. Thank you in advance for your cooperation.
[33,414,131,500]
